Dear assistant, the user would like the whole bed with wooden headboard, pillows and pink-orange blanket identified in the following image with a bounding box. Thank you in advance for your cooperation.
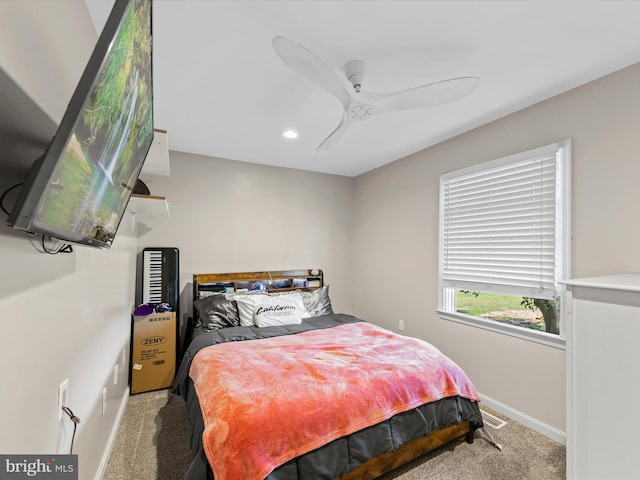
[172,269,483,480]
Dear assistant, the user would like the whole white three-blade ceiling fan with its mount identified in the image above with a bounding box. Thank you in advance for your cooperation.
[272,37,480,153]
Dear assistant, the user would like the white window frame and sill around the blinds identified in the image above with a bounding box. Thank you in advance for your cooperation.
[436,139,572,349]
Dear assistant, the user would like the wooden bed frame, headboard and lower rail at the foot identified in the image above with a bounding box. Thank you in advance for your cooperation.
[193,269,474,480]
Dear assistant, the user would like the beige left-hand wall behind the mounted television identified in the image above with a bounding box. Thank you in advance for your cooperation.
[0,1,137,479]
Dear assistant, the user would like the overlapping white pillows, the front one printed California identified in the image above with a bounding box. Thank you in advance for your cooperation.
[235,294,307,327]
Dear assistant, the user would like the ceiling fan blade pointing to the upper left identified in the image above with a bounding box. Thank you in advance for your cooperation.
[271,37,351,110]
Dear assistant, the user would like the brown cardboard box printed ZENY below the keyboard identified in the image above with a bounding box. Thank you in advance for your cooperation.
[131,312,176,393]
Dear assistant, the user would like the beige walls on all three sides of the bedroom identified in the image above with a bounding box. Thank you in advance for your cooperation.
[0,1,640,464]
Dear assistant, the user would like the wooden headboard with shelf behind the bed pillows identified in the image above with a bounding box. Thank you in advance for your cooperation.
[193,269,324,300]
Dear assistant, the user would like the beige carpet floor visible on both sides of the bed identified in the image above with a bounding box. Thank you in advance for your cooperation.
[104,390,566,480]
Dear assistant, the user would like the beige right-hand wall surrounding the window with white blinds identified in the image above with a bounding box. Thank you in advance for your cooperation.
[353,65,640,432]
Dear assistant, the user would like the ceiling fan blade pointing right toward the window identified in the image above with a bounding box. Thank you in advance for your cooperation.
[369,77,480,113]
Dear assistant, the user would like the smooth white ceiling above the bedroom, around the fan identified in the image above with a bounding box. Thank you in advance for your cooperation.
[86,0,640,176]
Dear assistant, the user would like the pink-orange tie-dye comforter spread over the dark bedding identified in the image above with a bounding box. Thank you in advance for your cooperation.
[190,322,479,480]
